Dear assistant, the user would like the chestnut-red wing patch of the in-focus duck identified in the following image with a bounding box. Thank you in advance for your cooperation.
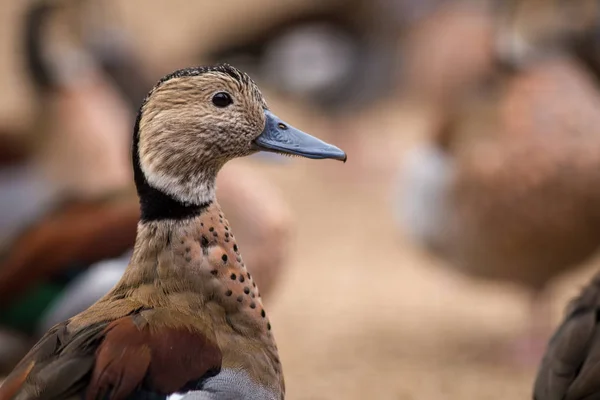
[86,314,222,400]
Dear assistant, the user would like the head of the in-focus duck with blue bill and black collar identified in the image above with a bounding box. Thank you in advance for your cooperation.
[133,64,346,219]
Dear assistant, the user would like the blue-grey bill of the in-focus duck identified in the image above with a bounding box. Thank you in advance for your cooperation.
[253,110,347,162]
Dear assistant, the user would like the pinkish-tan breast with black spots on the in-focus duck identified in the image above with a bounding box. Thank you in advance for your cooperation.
[165,202,285,394]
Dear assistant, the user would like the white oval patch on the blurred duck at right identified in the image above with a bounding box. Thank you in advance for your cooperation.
[394,145,455,244]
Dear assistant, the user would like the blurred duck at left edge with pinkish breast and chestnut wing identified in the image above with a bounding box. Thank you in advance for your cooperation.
[0,1,138,338]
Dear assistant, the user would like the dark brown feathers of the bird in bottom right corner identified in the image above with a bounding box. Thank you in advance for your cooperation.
[534,275,600,400]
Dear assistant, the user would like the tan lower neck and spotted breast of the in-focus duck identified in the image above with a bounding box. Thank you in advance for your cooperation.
[108,202,285,399]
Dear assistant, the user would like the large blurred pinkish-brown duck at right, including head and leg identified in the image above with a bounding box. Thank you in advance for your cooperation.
[396,1,600,366]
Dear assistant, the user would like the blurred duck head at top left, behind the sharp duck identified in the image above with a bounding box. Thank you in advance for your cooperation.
[23,0,152,110]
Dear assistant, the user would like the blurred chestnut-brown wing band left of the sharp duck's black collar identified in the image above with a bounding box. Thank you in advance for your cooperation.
[0,192,139,309]
